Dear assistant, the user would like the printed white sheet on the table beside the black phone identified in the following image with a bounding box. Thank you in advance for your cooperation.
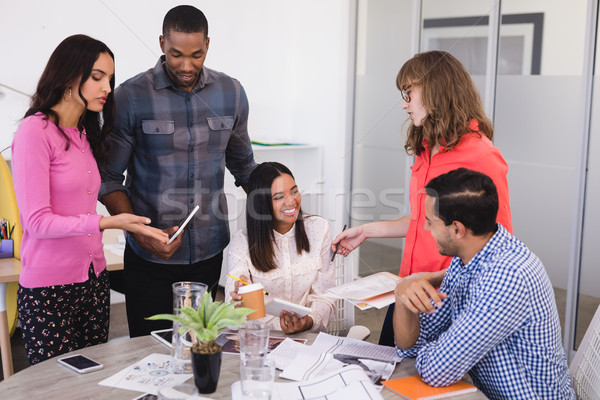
[98,353,192,394]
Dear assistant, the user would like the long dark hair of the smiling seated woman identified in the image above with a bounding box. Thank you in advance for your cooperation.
[246,162,310,272]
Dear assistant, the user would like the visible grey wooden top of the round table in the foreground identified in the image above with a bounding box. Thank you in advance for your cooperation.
[0,333,486,400]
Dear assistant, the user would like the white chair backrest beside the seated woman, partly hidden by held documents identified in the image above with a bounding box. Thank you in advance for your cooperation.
[327,254,354,336]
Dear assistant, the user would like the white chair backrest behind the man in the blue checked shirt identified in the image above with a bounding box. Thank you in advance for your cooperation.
[569,307,600,400]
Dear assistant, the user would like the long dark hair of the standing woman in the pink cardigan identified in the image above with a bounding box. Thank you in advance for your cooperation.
[24,35,115,165]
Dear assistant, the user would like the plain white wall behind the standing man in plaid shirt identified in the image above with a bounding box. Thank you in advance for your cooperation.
[0,0,354,229]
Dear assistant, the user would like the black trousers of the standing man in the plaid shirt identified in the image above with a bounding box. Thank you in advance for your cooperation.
[124,245,223,337]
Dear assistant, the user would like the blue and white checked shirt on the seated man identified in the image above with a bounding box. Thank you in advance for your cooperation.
[397,224,575,400]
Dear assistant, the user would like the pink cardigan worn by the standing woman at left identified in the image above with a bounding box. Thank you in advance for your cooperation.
[12,113,106,288]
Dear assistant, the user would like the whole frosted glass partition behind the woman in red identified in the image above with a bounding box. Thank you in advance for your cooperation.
[351,0,600,350]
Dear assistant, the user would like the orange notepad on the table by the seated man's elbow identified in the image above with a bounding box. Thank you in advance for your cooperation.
[382,375,477,400]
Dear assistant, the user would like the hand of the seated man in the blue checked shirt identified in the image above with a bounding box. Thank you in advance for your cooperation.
[394,273,446,314]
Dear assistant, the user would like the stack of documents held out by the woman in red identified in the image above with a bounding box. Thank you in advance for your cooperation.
[325,272,402,310]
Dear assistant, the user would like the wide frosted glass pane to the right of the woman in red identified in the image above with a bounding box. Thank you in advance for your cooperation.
[494,0,587,344]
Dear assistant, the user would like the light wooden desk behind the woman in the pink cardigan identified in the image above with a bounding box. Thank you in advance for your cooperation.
[0,229,123,378]
